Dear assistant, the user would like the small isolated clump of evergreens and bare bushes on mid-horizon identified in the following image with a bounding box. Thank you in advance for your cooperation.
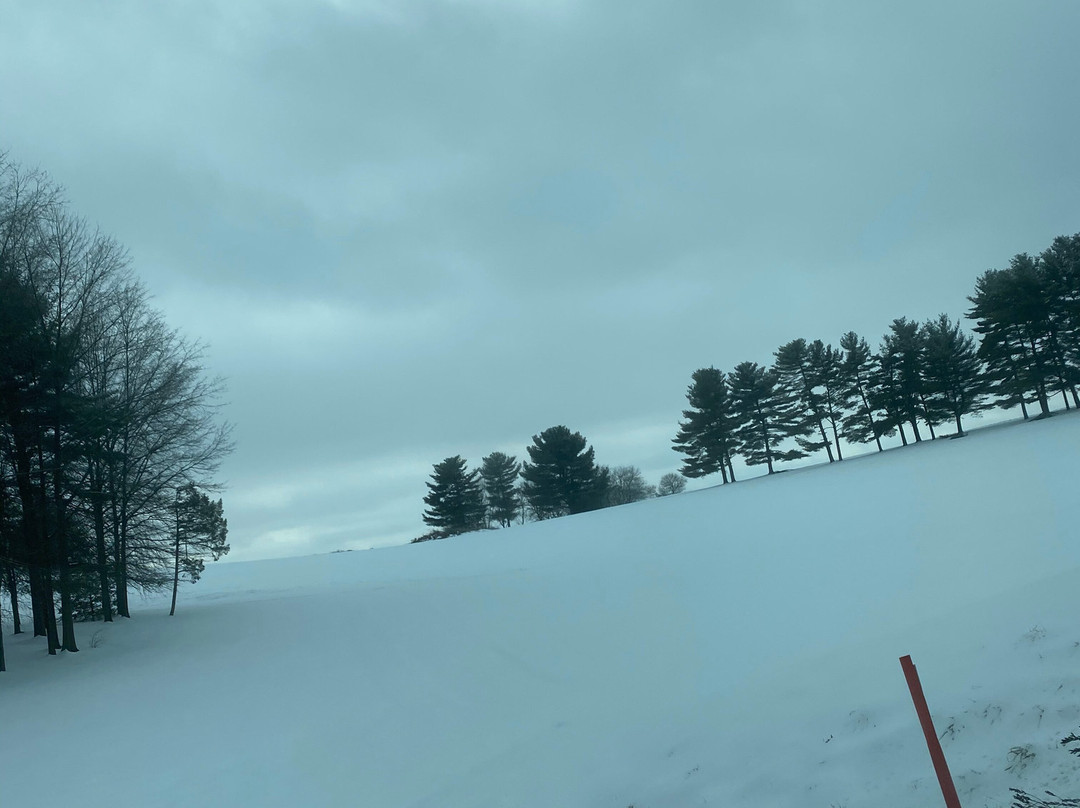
[414,426,673,541]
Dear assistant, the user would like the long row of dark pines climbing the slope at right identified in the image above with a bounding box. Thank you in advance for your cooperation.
[673,233,1080,483]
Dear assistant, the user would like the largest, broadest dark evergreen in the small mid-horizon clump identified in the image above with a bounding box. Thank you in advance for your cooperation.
[522,426,608,520]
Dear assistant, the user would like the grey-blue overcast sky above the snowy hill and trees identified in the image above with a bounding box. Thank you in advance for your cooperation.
[0,0,1080,558]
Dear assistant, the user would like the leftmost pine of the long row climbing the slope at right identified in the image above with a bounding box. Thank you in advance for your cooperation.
[672,367,735,483]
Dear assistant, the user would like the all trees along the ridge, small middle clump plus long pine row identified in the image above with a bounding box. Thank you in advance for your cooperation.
[420,233,1080,540]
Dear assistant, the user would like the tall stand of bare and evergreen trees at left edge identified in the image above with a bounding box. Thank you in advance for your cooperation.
[0,154,231,670]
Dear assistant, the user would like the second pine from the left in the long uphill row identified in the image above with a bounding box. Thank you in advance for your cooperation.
[729,362,806,474]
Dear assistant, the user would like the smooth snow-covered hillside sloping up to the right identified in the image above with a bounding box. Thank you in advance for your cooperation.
[0,415,1080,808]
